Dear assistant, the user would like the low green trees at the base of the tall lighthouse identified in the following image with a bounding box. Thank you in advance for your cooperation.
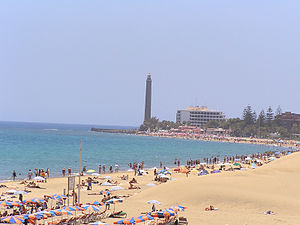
[139,117,182,131]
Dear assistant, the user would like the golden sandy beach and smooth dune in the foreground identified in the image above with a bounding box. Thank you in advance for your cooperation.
[0,152,300,225]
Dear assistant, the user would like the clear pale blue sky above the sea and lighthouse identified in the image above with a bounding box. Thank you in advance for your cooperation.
[0,0,300,126]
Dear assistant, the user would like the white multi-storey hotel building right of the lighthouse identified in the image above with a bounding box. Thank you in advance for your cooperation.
[176,106,225,127]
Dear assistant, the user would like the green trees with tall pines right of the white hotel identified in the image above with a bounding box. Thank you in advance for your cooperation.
[206,105,300,139]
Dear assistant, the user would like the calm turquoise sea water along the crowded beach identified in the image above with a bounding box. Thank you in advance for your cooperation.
[0,122,284,179]
